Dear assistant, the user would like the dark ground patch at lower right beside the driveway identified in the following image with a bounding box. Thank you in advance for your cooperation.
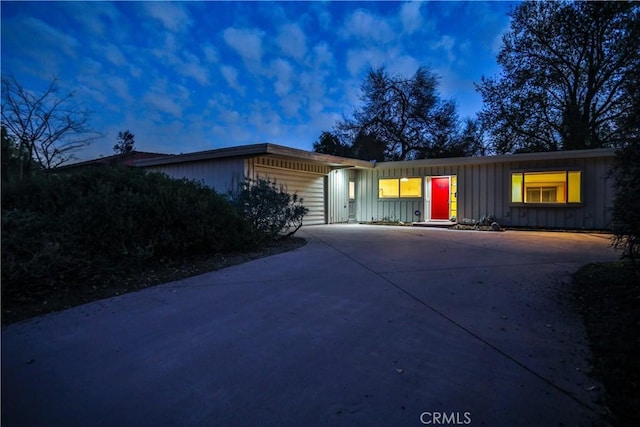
[573,261,640,426]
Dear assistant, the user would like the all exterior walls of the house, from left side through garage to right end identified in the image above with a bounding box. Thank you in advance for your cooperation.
[143,145,614,229]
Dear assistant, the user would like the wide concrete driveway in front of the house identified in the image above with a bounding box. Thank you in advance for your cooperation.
[2,225,617,427]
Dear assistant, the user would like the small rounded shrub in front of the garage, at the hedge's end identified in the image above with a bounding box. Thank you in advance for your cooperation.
[231,178,309,243]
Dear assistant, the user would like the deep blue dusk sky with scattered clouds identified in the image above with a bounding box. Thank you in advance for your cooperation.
[1,1,516,159]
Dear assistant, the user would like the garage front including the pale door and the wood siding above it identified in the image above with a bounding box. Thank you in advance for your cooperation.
[246,157,330,225]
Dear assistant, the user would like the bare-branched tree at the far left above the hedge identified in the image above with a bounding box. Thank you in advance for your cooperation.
[2,77,98,179]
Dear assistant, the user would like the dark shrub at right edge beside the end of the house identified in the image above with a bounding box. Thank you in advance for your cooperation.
[612,141,640,269]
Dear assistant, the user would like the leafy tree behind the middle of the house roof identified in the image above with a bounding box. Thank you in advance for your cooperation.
[336,67,458,160]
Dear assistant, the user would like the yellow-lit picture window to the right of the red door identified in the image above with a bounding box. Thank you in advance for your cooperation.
[511,171,582,204]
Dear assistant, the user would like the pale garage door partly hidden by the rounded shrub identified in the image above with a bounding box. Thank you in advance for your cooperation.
[256,165,325,225]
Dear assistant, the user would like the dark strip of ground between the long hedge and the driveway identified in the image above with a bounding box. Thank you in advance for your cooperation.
[2,237,306,326]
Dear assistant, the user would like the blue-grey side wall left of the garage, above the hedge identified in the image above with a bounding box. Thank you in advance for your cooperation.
[145,158,245,193]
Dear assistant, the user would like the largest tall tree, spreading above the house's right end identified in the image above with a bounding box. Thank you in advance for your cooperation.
[477,1,640,153]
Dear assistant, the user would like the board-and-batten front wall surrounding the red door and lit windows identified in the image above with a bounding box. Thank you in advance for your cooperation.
[356,156,613,229]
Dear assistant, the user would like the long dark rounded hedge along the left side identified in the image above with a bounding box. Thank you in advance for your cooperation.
[2,166,252,291]
